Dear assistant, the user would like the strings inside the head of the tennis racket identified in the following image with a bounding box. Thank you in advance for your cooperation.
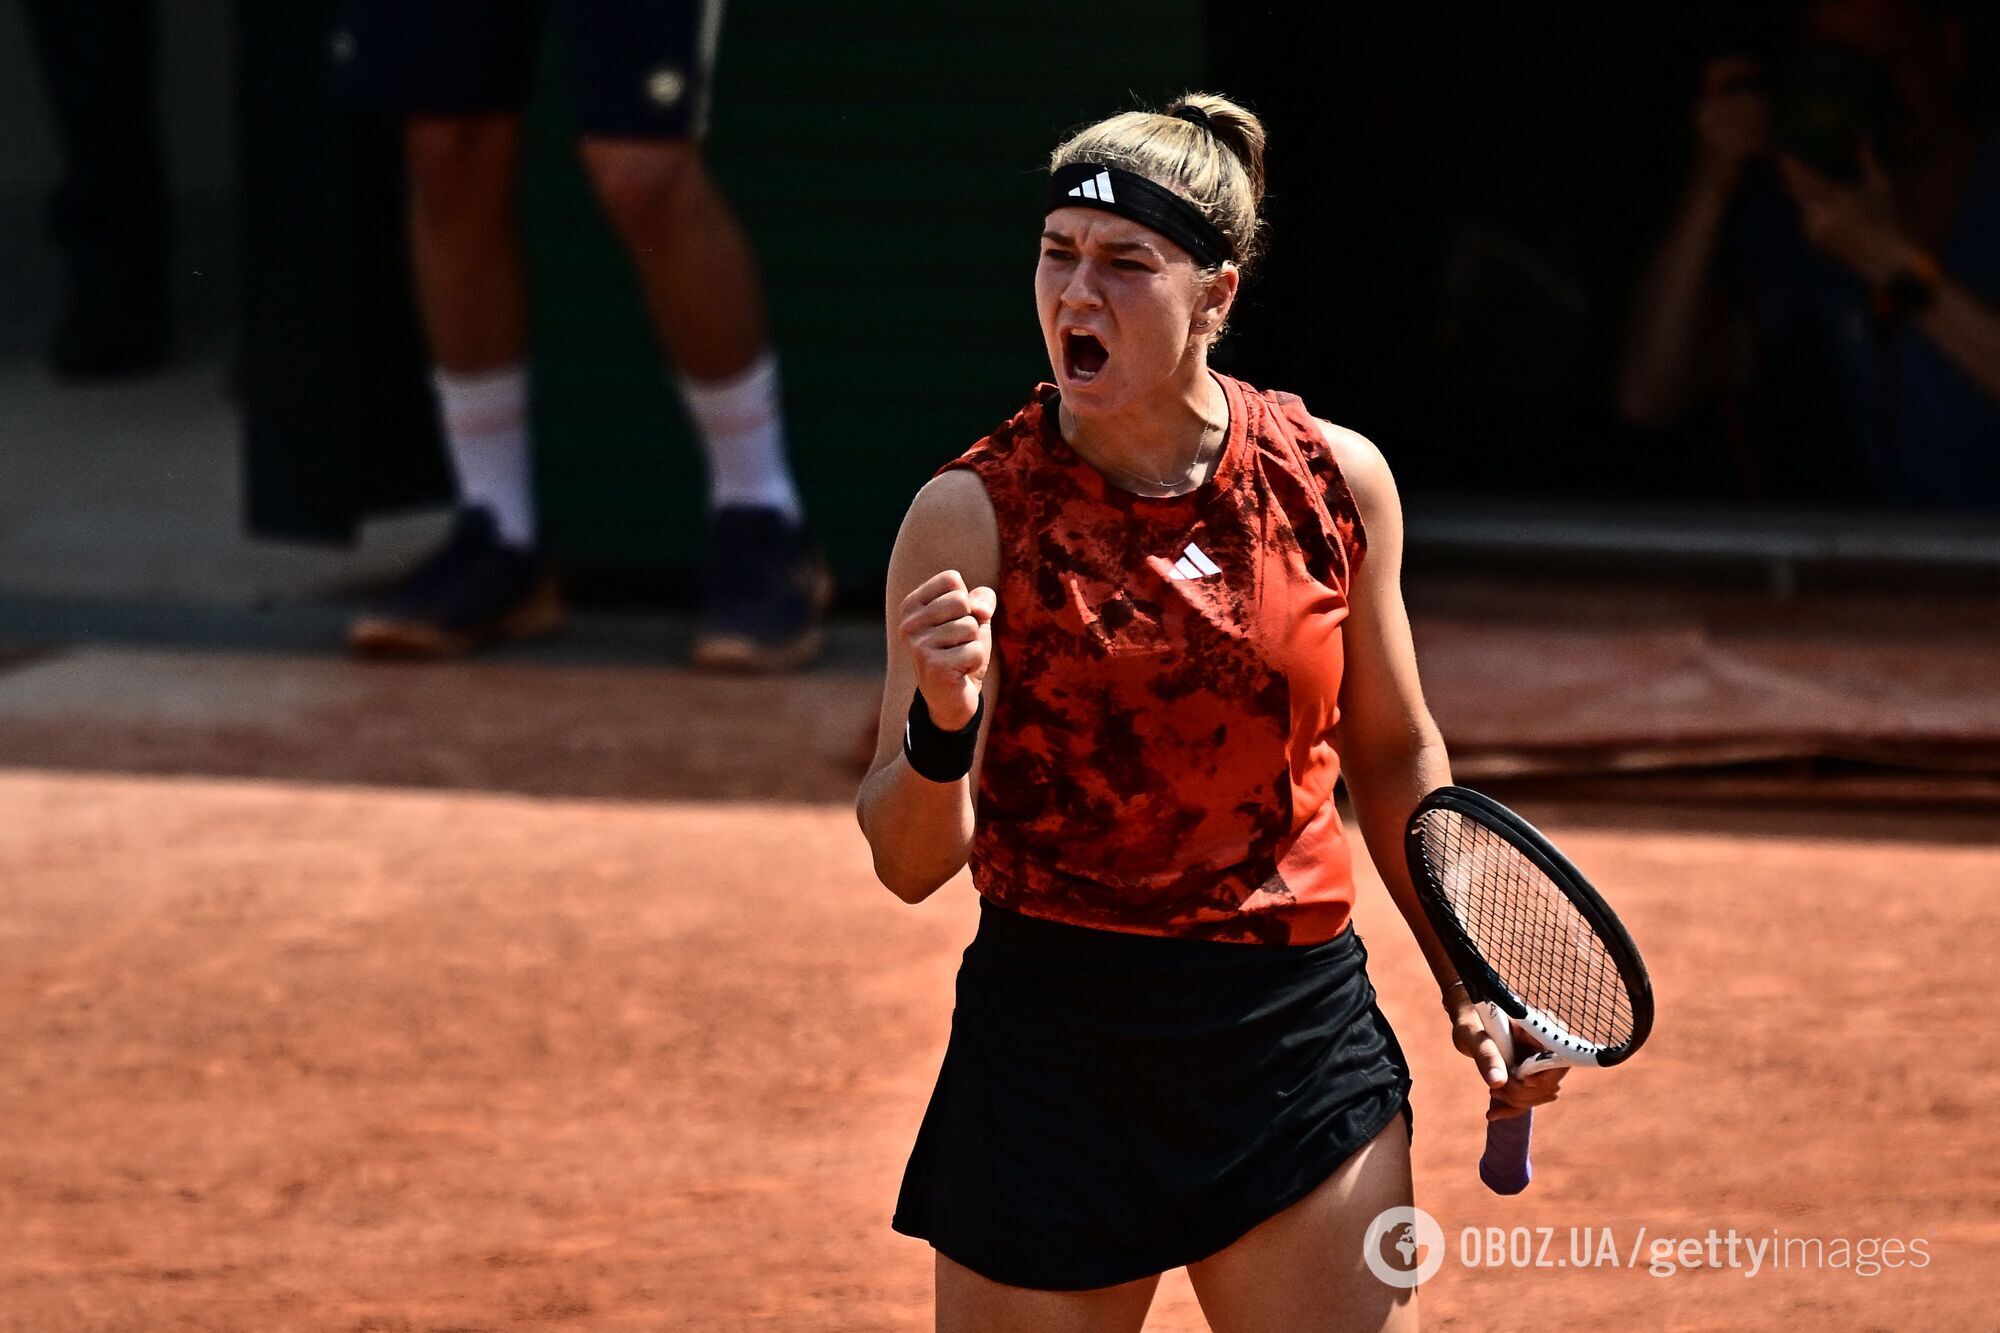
[1420,809,1636,1049]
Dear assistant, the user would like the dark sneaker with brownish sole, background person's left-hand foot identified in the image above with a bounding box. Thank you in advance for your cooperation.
[348,508,562,656]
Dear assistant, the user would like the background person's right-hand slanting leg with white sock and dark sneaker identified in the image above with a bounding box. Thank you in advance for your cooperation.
[554,0,832,669]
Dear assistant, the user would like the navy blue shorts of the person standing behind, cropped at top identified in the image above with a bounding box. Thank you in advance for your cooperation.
[334,0,722,138]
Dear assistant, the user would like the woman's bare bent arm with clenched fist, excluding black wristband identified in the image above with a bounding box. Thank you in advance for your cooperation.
[854,468,1000,903]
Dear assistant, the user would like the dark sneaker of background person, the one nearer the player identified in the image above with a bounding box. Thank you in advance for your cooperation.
[694,508,834,671]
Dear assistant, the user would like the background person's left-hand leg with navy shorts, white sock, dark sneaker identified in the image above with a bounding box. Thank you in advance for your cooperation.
[336,0,562,656]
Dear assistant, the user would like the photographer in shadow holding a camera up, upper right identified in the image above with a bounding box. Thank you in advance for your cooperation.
[1618,0,2000,506]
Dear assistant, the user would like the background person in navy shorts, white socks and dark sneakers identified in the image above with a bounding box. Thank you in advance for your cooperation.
[334,0,830,669]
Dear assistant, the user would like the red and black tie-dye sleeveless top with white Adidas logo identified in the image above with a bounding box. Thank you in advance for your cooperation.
[944,374,1366,945]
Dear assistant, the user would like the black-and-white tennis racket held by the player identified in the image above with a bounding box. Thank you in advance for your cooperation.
[1404,787,1652,1195]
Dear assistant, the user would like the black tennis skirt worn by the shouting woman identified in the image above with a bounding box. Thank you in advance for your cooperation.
[894,899,1410,1291]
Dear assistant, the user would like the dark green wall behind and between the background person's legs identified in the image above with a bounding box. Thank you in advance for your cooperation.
[526,0,1204,594]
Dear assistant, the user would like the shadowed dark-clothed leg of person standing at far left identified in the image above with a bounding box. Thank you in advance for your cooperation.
[26,0,172,380]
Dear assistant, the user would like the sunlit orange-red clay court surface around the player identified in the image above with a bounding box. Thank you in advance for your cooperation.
[0,771,2000,1331]
